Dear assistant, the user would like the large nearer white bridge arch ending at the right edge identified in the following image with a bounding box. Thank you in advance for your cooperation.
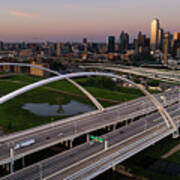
[0,72,179,135]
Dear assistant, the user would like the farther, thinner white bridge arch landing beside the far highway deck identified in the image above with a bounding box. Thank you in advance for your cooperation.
[0,63,104,111]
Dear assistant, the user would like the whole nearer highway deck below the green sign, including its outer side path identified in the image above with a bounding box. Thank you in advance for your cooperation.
[2,104,180,180]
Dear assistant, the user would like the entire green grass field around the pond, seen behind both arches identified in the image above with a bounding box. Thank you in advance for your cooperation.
[0,72,145,132]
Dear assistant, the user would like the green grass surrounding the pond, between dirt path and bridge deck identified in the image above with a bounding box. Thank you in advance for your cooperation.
[0,83,91,132]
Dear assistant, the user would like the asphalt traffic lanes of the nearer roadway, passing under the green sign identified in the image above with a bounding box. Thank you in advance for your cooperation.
[2,104,180,180]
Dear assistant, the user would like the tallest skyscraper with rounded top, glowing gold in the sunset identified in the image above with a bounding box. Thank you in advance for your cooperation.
[151,18,160,50]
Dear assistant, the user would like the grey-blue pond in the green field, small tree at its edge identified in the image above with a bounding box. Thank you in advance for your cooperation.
[22,100,94,117]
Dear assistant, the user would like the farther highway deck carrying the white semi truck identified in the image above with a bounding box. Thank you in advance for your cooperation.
[0,88,179,164]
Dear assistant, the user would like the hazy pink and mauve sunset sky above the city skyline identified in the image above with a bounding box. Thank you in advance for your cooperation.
[0,0,180,41]
